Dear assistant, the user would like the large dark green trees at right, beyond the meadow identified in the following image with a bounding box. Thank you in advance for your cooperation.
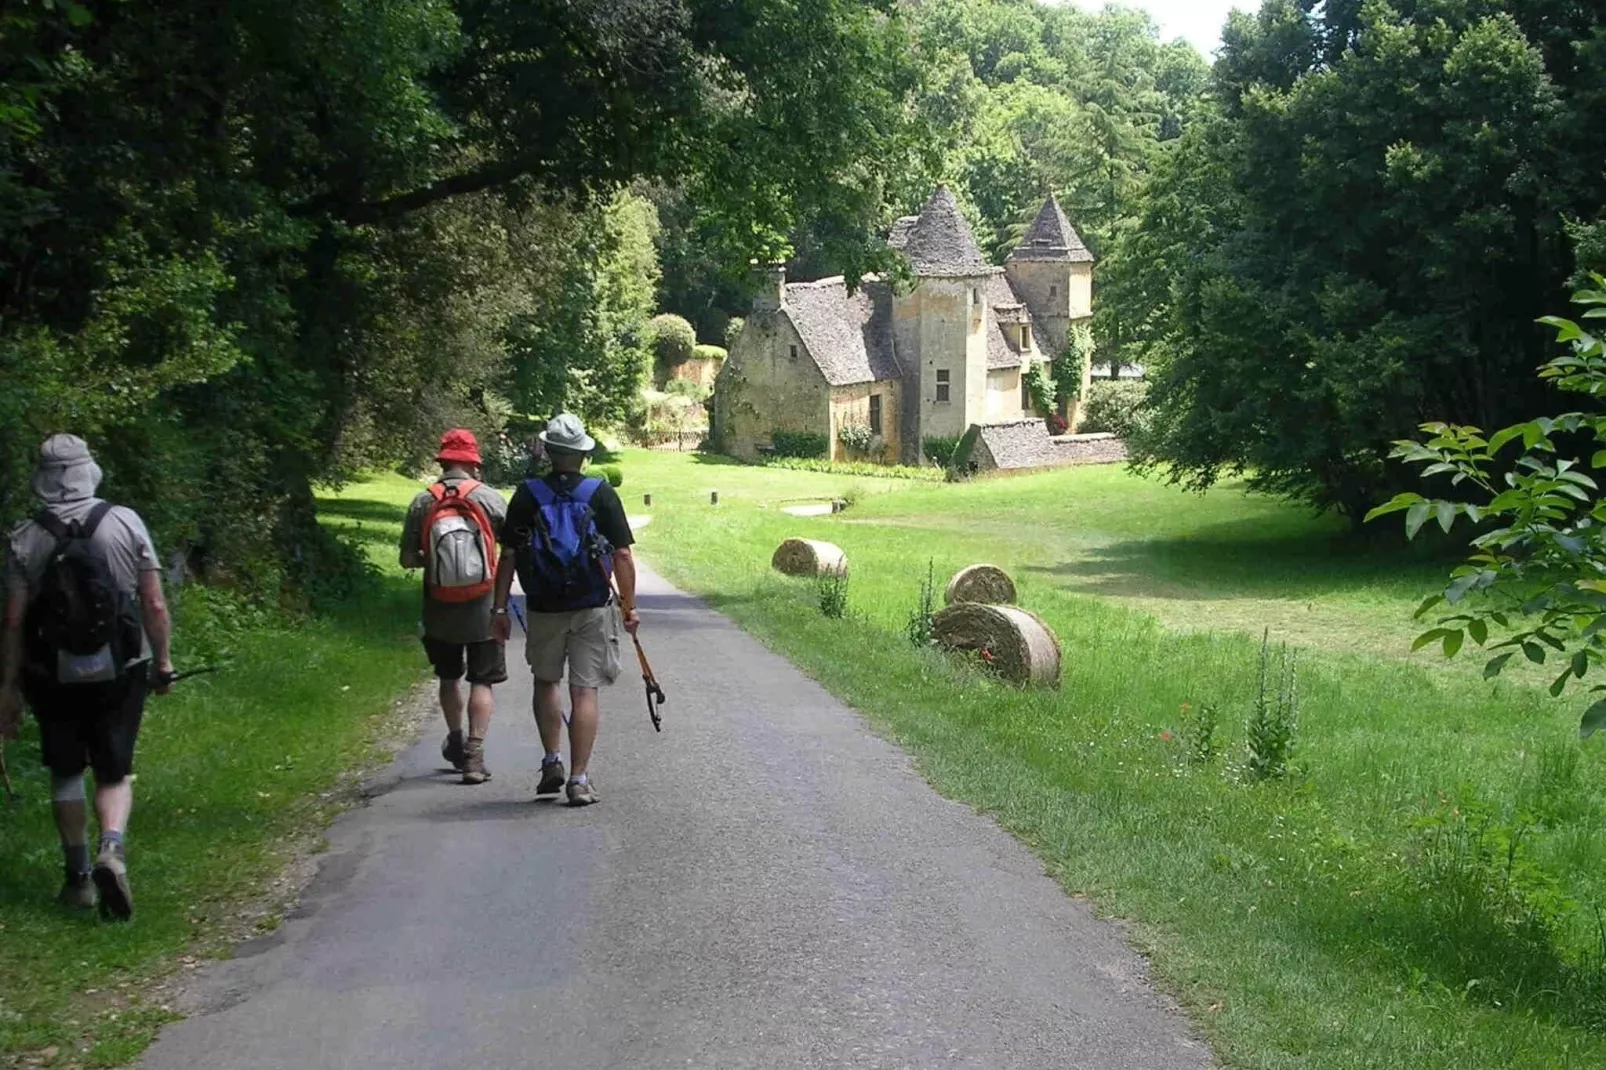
[1124,0,1606,519]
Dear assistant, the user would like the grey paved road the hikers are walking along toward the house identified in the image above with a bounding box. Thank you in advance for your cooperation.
[141,562,1211,1070]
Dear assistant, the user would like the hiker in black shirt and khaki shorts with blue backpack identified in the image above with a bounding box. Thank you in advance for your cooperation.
[493,413,641,807]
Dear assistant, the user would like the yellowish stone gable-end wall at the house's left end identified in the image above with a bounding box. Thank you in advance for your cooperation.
[713,312,835,461]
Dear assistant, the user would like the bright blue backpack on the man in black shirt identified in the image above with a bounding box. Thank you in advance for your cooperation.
[524,479,613,614]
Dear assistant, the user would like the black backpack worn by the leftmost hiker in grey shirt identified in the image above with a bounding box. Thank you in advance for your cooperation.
[26,501,141,684]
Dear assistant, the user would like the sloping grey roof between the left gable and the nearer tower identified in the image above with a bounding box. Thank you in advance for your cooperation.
[784,275,901,386]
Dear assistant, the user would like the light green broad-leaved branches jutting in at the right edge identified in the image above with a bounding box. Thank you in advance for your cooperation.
[1368,275,1606,736]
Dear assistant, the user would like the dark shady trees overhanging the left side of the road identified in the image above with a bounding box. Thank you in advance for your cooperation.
[0,0,917,590]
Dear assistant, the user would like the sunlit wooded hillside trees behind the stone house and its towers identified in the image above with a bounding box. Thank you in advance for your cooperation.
[654,0,1209,358]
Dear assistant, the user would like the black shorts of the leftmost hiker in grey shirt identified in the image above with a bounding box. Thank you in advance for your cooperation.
[24,664,149,786]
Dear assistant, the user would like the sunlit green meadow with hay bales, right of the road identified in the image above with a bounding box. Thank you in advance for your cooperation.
[626,455,1606,1070]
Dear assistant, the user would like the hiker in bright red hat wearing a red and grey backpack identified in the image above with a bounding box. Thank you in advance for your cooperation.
[402,427,507,784]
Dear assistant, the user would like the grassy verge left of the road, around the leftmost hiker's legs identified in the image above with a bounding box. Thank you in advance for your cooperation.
[0,480,419,1067]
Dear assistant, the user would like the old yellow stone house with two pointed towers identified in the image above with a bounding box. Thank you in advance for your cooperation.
[713,186,1094,464]
